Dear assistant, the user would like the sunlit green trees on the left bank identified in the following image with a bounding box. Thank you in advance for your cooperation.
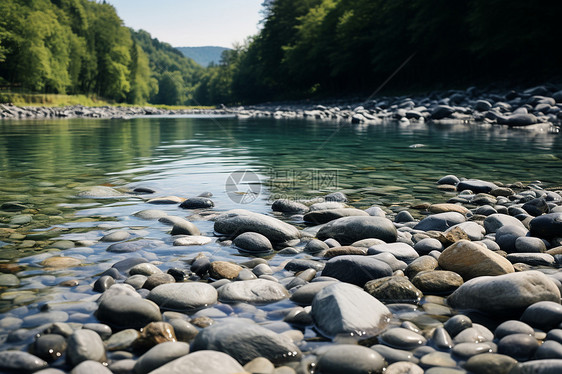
[0,0,204,105]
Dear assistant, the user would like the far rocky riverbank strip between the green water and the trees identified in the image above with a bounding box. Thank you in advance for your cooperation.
[0,85,562,131]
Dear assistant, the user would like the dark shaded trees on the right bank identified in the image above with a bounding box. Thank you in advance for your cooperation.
[197,0,562,103]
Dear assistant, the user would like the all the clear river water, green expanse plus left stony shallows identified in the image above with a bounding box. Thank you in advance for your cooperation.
[0,117,562,356]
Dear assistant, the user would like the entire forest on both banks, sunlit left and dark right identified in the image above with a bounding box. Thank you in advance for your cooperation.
[0,0,562,105]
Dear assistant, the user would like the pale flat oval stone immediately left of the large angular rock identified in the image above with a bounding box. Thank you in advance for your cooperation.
[218,279,289,304]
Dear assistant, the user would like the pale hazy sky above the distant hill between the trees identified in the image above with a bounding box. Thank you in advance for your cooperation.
[106,0,263,47]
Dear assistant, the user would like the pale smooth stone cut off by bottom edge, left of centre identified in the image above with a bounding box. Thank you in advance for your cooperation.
[150,350,244,374]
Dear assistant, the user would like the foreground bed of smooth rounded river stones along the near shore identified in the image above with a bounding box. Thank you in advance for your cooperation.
[0,175,562,374]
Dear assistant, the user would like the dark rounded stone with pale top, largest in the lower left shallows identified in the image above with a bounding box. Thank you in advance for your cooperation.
[95,294,161,329]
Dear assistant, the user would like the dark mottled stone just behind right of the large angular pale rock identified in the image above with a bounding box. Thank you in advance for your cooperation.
[364,276,423,303]
